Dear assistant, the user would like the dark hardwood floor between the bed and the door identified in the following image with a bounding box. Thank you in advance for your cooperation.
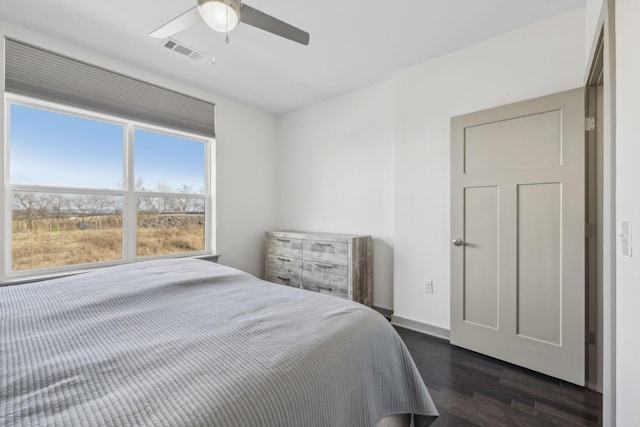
[396,327,602,427]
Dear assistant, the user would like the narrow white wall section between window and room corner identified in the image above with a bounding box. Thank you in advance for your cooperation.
[216,100,277,277]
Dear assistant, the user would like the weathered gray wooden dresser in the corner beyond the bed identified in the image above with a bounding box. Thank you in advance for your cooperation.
[265,231,373,307]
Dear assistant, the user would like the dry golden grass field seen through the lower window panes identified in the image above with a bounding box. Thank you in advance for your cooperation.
[11,218,204,271]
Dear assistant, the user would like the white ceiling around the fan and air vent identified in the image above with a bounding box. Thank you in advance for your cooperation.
[0,0,585,114]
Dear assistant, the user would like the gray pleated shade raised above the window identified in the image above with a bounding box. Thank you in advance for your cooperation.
[5,39,215,137]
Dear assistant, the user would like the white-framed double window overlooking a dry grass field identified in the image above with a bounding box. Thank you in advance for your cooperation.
[4,95,214,277]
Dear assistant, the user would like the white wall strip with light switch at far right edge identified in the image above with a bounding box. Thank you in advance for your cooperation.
[615,0,640,426]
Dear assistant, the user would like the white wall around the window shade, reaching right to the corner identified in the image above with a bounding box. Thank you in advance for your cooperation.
[0,22,277,276]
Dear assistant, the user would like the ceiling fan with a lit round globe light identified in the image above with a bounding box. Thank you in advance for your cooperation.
[149,0,309,46]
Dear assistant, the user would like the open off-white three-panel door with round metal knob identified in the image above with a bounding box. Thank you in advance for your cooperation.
[451,89,585,385]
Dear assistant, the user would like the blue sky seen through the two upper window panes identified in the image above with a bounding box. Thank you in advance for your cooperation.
[9,104,204,192]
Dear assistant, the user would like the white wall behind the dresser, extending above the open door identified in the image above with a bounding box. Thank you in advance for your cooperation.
[277,9,585,320]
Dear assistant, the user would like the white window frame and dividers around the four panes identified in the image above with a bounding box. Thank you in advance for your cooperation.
[0,92,216,283]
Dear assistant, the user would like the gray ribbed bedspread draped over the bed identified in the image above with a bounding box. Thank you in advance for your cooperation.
[0,259,437,427]
